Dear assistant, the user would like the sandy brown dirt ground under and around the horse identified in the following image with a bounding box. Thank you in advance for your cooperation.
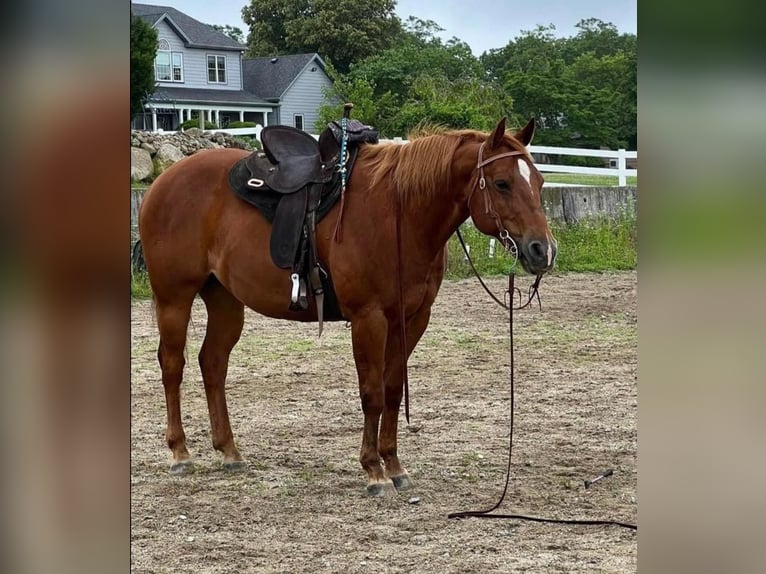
[131,272,637,574]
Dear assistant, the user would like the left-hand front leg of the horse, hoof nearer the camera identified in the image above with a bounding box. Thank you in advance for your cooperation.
[351,310,396,496]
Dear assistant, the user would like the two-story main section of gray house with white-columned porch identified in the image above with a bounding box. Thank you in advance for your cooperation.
[131,3,279,131]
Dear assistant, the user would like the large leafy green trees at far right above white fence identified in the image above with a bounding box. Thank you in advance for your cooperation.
[481,18,637,149]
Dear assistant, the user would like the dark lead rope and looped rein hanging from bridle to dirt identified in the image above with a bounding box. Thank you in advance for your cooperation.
[447,272,638,530]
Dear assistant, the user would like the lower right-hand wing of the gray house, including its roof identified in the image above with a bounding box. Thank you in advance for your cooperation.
[242,54,332,133]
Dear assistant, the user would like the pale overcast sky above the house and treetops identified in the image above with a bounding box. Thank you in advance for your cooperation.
[135,0,638,56]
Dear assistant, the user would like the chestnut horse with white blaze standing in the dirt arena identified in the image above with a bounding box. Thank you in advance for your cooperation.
[139,118,557,496]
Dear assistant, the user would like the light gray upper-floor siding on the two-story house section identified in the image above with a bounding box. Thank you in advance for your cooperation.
[156,20,242,90]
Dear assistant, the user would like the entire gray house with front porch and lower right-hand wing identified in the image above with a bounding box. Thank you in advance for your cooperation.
[131,3,332,132]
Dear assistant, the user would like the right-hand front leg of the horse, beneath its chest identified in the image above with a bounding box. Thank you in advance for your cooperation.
[378,305,431,490]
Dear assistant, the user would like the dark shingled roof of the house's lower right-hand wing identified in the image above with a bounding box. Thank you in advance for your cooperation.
[242,53,327,100]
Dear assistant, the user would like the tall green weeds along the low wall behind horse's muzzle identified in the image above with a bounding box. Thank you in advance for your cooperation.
[446,211,638,279]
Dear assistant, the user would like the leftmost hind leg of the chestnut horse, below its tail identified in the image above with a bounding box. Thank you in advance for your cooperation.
[155,290,196,473]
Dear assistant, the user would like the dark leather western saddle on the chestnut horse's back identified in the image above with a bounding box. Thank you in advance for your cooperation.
[229,104,378,335]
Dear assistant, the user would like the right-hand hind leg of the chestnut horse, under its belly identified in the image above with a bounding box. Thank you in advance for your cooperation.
[199,275,245,470]
